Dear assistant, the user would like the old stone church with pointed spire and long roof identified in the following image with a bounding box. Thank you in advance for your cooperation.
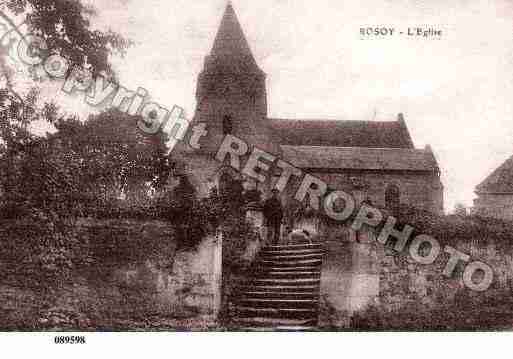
[173,4,443,214]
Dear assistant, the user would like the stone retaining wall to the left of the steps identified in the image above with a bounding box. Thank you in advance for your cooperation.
[0,220,222,330]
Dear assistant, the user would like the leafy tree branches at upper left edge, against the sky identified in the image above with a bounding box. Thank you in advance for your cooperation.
[0,0,130,211]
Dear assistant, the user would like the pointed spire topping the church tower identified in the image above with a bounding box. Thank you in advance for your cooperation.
[211,1,255,63]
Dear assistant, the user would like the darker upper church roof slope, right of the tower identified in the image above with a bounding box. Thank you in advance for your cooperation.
[269,115,414,149]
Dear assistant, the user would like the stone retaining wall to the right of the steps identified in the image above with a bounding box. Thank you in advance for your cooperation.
[320,221,513,330]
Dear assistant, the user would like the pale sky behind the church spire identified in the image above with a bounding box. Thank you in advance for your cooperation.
[29,0,513,211]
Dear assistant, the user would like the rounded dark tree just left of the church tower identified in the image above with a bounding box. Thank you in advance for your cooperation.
[49,109,172,208]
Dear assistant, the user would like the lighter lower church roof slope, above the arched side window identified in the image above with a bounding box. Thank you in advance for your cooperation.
[281,145,438,172]
